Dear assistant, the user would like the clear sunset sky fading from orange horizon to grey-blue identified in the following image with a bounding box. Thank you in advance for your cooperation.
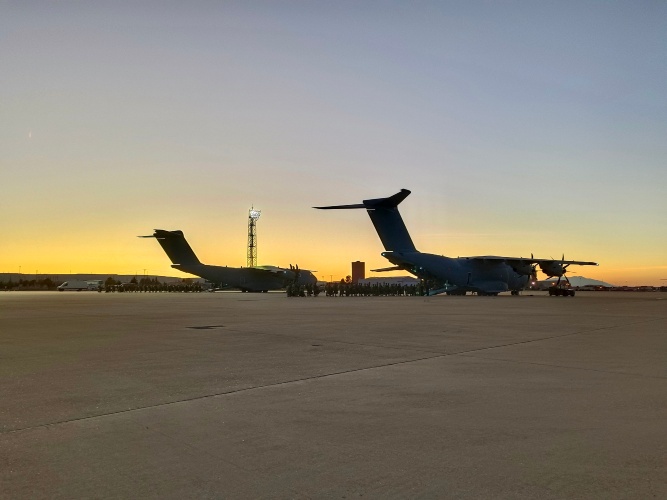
[0,0,667,285]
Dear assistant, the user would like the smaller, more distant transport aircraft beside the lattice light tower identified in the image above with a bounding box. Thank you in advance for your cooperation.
[139,229,317,292]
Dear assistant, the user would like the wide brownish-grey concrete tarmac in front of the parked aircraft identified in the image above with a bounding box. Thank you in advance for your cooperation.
[0,292,667,499]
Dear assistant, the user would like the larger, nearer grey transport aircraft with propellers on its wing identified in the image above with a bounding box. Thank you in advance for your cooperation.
[313,189,597,295]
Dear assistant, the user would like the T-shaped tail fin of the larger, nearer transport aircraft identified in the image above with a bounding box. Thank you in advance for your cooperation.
[313,189,417,252]
